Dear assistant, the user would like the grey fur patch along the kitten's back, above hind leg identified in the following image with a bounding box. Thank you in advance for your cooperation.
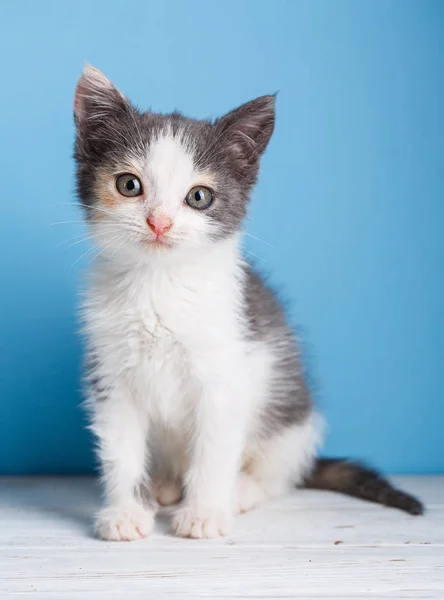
[245,266,313,438]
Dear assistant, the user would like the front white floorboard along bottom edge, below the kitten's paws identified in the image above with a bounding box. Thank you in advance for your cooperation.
[0,542,444,600]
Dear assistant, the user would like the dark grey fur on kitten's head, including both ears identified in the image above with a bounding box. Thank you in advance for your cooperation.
[74,67,275,238]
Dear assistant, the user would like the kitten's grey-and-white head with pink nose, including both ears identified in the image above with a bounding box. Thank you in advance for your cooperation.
[74,66,275,254]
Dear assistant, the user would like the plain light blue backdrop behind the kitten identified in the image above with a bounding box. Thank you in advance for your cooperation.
[0,0,444,473]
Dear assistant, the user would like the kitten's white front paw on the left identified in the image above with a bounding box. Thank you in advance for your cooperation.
[96,505,155,542]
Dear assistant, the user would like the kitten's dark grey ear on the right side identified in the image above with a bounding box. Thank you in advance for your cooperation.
[215,95,276,180]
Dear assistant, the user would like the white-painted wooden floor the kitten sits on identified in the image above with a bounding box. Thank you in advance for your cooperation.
[0,477,444,600]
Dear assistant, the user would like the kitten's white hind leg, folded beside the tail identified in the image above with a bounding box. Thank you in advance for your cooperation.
[235,415,320,514]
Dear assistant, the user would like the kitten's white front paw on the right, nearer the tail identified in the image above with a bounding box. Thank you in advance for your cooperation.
[173,507,229,539]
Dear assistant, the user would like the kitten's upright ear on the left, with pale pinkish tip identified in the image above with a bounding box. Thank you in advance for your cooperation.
[74,65,128,129]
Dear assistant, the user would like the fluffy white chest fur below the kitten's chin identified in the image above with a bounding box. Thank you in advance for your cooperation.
[85,237,246,425]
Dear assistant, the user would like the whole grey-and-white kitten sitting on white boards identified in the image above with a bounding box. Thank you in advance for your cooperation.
[74,66,422,540]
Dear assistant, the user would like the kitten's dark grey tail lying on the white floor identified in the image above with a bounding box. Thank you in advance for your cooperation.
[302,458,424,515]
